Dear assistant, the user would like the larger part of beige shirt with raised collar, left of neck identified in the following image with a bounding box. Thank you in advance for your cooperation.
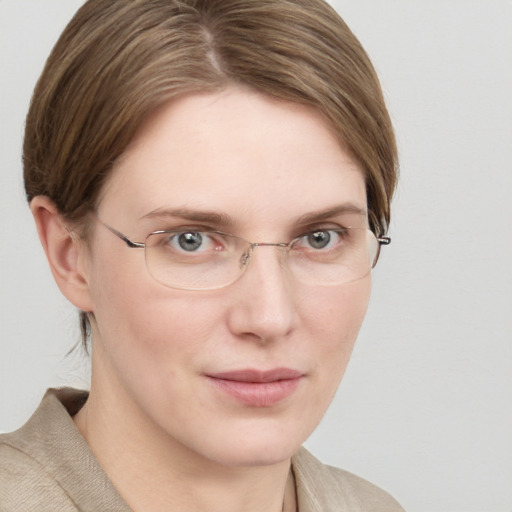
[0,388,130,512]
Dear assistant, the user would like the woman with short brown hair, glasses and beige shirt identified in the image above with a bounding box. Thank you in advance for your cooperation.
[0,0,401,512]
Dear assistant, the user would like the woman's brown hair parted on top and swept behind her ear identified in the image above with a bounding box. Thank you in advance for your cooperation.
[23,0,398,341]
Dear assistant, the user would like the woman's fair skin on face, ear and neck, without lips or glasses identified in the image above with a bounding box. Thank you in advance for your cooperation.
[31,88,370,512]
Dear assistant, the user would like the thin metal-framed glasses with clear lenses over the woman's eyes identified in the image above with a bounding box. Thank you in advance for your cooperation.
[96,217,391,290]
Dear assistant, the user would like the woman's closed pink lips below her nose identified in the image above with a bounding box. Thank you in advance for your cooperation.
[207,368,304,407]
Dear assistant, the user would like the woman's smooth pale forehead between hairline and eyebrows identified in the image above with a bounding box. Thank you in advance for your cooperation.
[101,88,366,228]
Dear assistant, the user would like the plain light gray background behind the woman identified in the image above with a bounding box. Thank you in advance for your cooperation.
[0,0,512,512]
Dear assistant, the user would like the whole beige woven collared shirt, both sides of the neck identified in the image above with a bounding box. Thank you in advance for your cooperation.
[0,388,403,512]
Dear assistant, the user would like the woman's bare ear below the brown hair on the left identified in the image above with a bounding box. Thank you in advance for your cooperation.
[30,196,93,312]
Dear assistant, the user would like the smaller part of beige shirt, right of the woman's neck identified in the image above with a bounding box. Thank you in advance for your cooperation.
[292,448,403,512]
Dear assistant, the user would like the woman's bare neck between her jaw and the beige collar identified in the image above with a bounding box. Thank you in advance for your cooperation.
[75,364,296,512]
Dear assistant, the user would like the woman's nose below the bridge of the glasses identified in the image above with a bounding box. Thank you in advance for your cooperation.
[228,244,299,342]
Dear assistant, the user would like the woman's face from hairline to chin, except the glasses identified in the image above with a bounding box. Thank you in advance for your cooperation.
[86,88,370,466]
